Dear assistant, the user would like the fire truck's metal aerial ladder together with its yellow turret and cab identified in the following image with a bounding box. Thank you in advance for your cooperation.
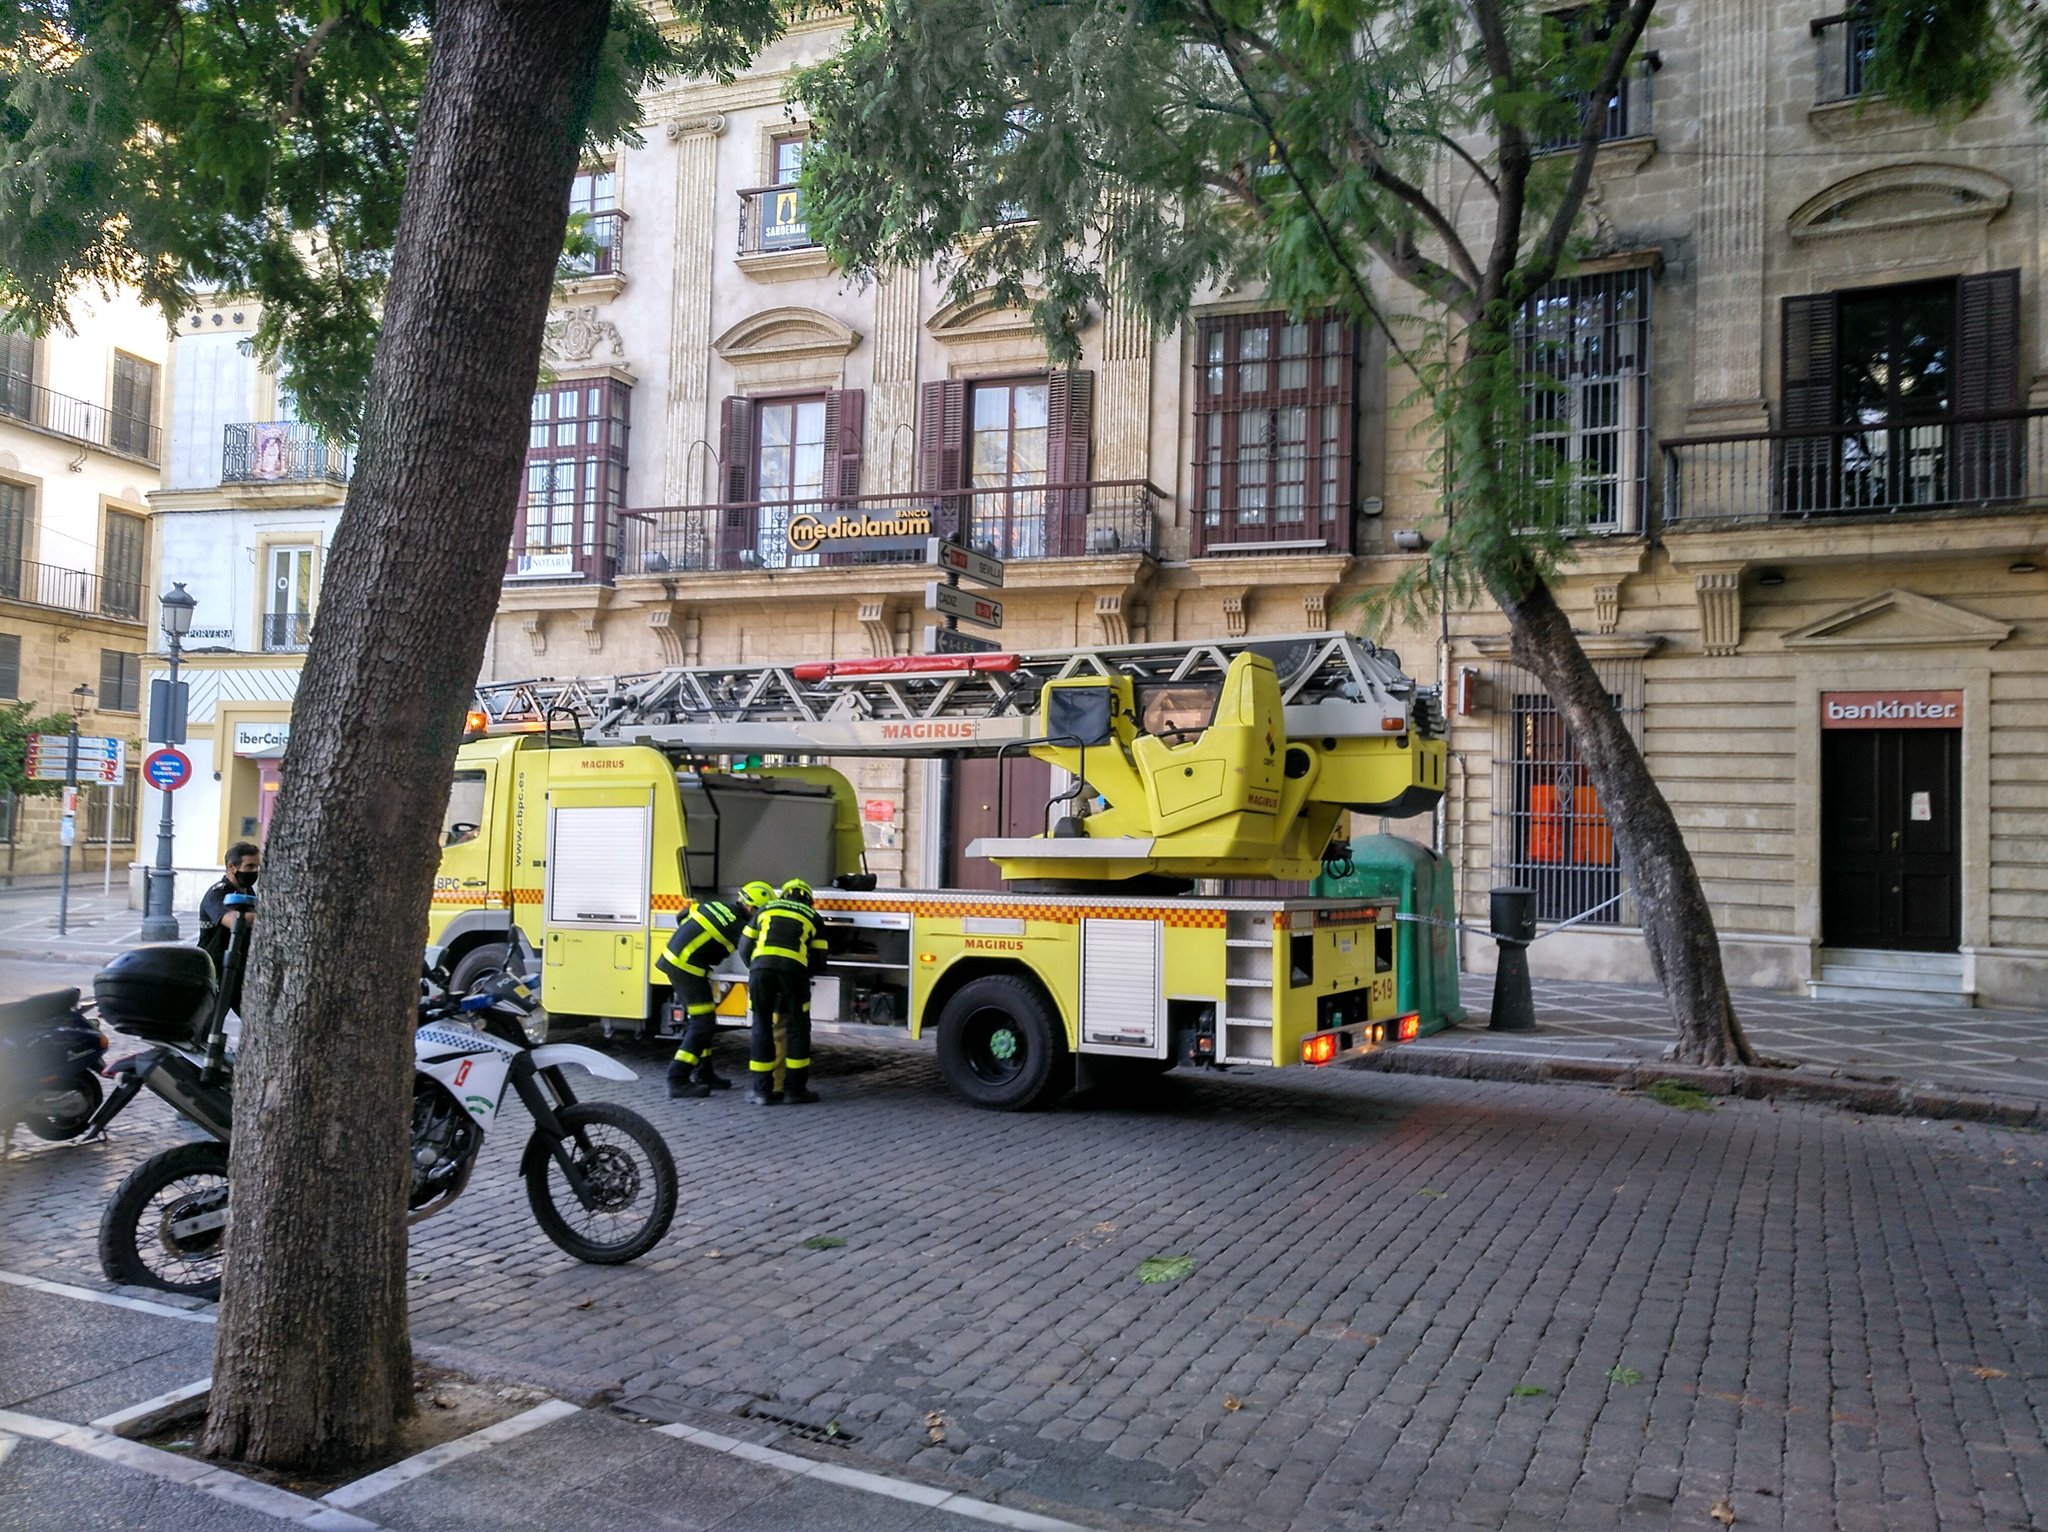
[479,633,1444,891]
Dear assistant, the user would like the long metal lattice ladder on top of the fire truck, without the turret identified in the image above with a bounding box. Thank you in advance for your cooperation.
[477,633,1444,758]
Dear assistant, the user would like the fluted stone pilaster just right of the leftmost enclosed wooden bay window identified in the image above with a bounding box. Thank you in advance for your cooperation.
[662,113,725,506]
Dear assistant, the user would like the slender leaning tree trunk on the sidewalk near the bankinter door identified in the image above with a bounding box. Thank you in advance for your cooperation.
[1493,580,1757,1065]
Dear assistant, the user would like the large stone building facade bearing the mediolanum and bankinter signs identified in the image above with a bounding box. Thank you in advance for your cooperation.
[485,0,2048,1004]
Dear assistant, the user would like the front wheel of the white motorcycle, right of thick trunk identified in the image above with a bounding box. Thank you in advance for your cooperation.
[520,1102,676,1266]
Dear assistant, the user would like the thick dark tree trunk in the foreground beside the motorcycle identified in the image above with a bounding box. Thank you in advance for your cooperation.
[205,0,610,1469]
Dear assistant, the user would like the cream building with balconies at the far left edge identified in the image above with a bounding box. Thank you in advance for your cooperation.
[0,291,170,877]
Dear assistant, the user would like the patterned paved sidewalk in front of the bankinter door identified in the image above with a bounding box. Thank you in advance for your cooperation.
[1450,973,2048,1096]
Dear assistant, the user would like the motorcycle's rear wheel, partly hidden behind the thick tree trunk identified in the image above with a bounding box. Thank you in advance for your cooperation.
[100,1139,227,1299]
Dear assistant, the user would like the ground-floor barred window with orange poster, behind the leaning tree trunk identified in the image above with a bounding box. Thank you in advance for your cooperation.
[1493,659,1642,926]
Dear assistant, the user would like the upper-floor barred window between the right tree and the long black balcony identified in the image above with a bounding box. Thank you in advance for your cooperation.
[1518,268,1651,533]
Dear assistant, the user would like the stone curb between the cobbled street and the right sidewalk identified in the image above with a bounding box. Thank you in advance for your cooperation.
[1352,1045,2048,1129]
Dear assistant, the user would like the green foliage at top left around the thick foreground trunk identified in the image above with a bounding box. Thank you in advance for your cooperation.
[0,0,688,440]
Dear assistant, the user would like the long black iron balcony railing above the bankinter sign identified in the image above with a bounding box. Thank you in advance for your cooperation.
[1659,410,2048,530]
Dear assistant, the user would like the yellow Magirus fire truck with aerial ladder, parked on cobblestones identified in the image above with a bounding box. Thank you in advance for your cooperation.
[430,633,1444,1110]
